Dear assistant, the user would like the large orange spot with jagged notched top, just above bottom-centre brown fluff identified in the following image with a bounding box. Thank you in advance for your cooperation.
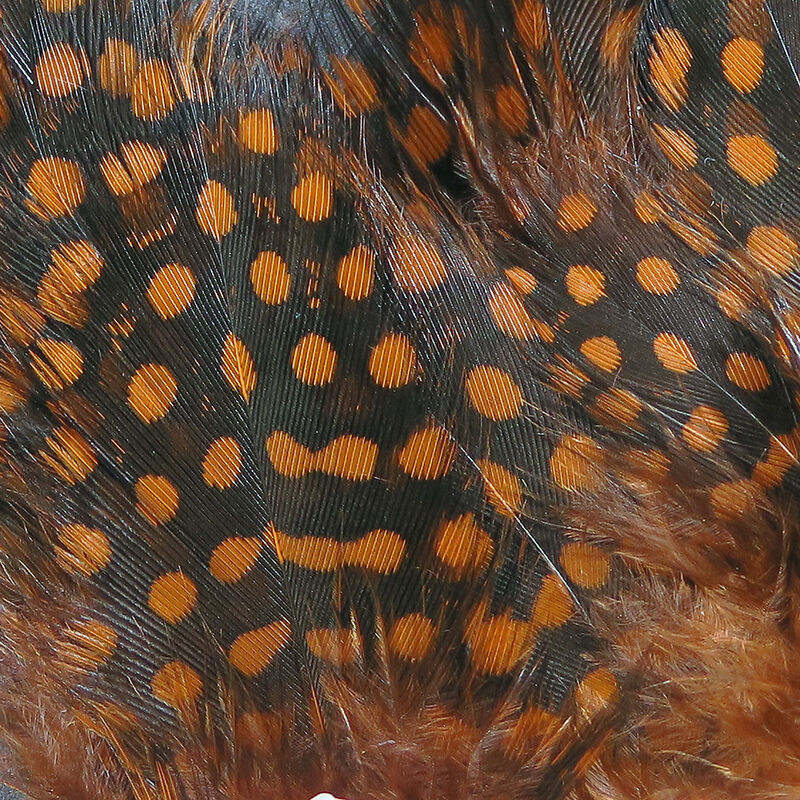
[464,603,536,675]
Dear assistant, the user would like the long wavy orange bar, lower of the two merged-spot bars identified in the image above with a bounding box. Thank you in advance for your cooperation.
[268,529,406,575]
